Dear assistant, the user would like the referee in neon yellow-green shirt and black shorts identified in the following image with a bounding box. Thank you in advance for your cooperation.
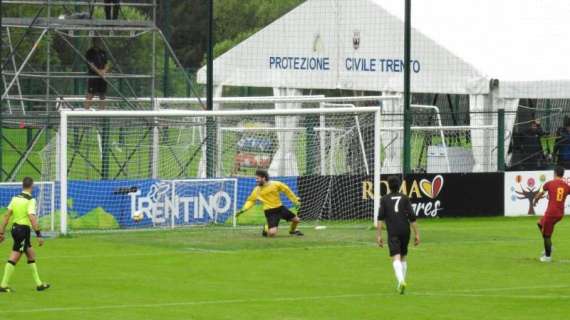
[0,177,49,292]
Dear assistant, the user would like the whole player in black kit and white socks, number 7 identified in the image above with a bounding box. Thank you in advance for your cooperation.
[376,177,420,294]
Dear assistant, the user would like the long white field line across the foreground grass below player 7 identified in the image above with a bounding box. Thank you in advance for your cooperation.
[4,286,570,314]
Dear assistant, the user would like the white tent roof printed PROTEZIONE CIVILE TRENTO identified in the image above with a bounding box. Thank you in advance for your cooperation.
[199,0,570,98]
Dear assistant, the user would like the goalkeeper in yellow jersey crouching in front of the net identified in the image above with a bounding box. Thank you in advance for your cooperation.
[237,170,303,237]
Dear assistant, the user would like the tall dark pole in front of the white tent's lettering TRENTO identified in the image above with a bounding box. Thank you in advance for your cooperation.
[403,0,412,174]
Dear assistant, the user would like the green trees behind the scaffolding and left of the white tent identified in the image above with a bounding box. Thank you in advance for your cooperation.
[1,0,305,95]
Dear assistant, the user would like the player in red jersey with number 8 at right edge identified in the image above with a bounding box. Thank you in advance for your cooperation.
[534,166,570,262]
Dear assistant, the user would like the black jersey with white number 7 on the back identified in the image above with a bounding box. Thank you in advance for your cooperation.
[378,193,416,236]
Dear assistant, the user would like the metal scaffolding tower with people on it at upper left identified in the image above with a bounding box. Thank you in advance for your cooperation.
[0,0,202,181]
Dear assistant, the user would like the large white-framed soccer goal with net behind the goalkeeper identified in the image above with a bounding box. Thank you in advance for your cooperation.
[55,106,381,234]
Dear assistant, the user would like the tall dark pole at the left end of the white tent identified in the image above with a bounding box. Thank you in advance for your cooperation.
[206,0,216,178]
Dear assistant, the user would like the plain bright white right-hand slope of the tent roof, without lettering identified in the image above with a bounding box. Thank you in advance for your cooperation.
[378,0,570,81]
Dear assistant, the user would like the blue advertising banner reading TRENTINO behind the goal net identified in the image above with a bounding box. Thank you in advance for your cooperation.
[44,179,238,229]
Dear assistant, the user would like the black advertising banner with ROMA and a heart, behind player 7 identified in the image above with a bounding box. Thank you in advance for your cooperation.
[299,173,504,220]
